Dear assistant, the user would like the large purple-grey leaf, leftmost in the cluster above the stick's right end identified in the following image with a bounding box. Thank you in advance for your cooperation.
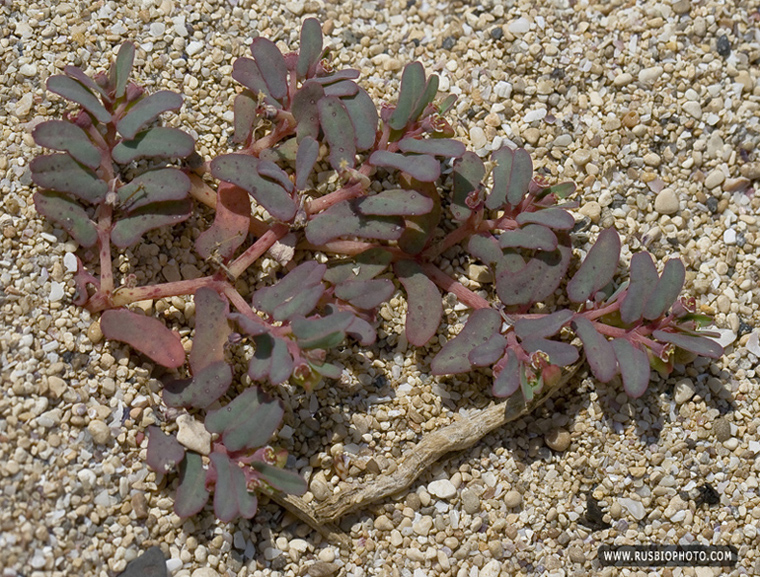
[430,309,502,375]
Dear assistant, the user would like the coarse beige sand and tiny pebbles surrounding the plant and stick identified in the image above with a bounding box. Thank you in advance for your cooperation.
[0,0,760,577]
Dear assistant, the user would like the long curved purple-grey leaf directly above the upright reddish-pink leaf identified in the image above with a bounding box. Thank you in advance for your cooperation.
[211,154,298,222]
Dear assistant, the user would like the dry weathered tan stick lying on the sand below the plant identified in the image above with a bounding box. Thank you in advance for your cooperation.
[272,360,582,547]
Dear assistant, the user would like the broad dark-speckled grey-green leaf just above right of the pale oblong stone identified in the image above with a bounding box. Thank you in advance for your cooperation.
[206,387,284,451]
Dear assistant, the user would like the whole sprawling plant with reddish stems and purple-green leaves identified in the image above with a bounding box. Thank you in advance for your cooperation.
[31,19,722,521]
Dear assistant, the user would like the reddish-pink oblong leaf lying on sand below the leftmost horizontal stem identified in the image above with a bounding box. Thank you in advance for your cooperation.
[100,309,185,369]
